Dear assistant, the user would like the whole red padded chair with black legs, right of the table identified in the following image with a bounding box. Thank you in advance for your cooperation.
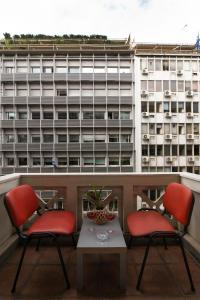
[127,183,195,291]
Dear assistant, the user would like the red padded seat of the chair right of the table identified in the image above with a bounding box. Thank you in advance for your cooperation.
[127,211,175,236]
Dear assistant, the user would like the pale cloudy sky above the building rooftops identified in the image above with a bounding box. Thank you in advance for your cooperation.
[0,0,200,44]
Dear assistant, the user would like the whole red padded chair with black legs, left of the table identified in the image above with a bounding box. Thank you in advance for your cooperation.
[4,184,75,293]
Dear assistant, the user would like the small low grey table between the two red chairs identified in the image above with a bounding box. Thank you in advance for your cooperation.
[77,217,127,289]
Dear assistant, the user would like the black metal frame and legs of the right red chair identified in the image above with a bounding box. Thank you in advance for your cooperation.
[128,199,195,292]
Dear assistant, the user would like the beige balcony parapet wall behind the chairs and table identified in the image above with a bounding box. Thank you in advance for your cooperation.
[0,173,200,258]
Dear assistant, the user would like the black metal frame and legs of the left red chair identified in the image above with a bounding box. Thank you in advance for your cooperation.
[4,199,76,293]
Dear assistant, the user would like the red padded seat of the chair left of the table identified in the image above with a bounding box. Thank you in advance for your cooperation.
[27,210,75,235]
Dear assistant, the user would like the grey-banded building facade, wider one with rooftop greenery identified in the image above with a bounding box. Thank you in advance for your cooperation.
[0,41,135,174]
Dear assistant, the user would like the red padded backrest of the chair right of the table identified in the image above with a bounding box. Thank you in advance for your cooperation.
[163,182,194,226]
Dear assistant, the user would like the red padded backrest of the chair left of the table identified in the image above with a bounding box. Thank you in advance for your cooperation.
[5,184,39,228]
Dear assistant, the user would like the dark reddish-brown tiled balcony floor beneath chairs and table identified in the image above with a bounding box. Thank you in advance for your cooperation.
[0,245,200,300]
